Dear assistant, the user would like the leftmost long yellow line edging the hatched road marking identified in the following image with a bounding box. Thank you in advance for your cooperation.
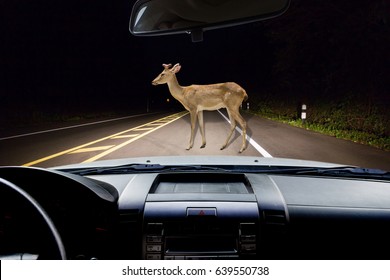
[23,112,188,166]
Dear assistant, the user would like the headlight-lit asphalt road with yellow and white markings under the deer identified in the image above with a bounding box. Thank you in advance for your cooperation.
[0,110,390,171]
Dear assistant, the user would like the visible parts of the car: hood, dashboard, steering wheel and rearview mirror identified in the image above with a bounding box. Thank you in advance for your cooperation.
[0,0,390,260]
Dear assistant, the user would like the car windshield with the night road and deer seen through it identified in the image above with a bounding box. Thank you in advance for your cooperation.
[0,0,390,171]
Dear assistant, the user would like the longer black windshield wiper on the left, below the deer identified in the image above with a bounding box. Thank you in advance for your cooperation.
[62,163,229,176]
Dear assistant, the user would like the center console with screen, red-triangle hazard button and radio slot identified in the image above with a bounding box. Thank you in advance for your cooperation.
[142,173,259,260]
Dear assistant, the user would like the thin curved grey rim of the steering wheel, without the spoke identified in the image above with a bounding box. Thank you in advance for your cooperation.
[0,178,66,260]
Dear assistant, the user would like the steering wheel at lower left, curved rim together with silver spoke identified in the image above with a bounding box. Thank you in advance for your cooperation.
[0,178,66,260]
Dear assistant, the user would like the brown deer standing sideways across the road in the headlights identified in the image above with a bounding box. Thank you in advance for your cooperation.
[152,63,248,153]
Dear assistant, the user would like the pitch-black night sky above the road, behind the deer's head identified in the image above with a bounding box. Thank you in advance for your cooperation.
[0,0,390,127]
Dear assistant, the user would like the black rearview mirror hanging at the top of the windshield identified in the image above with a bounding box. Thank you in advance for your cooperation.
[130,0,290,41]
